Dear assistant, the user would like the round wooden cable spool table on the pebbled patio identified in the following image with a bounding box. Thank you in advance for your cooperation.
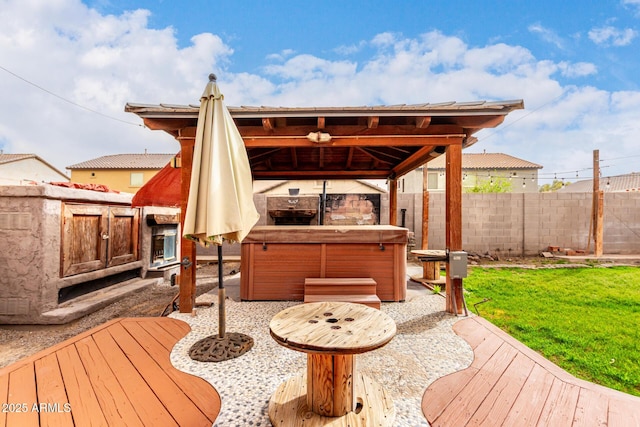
[269,302,396,427]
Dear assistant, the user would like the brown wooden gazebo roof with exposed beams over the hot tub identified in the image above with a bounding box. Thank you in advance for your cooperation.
[125,100,524,180]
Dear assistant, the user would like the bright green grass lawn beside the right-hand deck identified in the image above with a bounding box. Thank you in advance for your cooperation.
[464,267,640,396]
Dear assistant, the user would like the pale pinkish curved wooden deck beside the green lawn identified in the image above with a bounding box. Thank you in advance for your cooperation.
[422,317,640,427]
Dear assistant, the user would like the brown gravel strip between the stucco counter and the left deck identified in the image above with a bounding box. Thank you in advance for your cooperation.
[0,263,240,368]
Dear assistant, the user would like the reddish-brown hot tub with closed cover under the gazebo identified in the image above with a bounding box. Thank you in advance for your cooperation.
[240,225,408,301]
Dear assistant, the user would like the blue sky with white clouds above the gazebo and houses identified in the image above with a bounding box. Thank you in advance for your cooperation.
[0,0,640,185]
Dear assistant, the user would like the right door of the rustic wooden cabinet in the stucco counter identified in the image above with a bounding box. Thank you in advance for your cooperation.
[107,207,140,267]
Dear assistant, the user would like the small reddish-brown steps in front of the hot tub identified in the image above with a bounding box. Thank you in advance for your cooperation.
[304,277,380,310]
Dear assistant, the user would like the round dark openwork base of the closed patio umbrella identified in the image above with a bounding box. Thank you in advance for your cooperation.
[189,332,253,362]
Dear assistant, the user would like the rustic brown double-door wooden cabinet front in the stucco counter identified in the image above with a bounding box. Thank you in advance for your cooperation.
[60,203,140,277]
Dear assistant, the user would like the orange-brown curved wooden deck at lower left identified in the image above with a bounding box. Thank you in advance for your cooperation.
[0,317,220,427]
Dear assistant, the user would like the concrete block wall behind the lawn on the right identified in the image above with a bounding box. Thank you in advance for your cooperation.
[398,192,640,256]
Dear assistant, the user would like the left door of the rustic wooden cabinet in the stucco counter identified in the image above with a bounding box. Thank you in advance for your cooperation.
[61,204,109,276]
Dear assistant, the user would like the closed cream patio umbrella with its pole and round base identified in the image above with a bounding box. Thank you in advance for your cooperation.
[183,74,260,361]
